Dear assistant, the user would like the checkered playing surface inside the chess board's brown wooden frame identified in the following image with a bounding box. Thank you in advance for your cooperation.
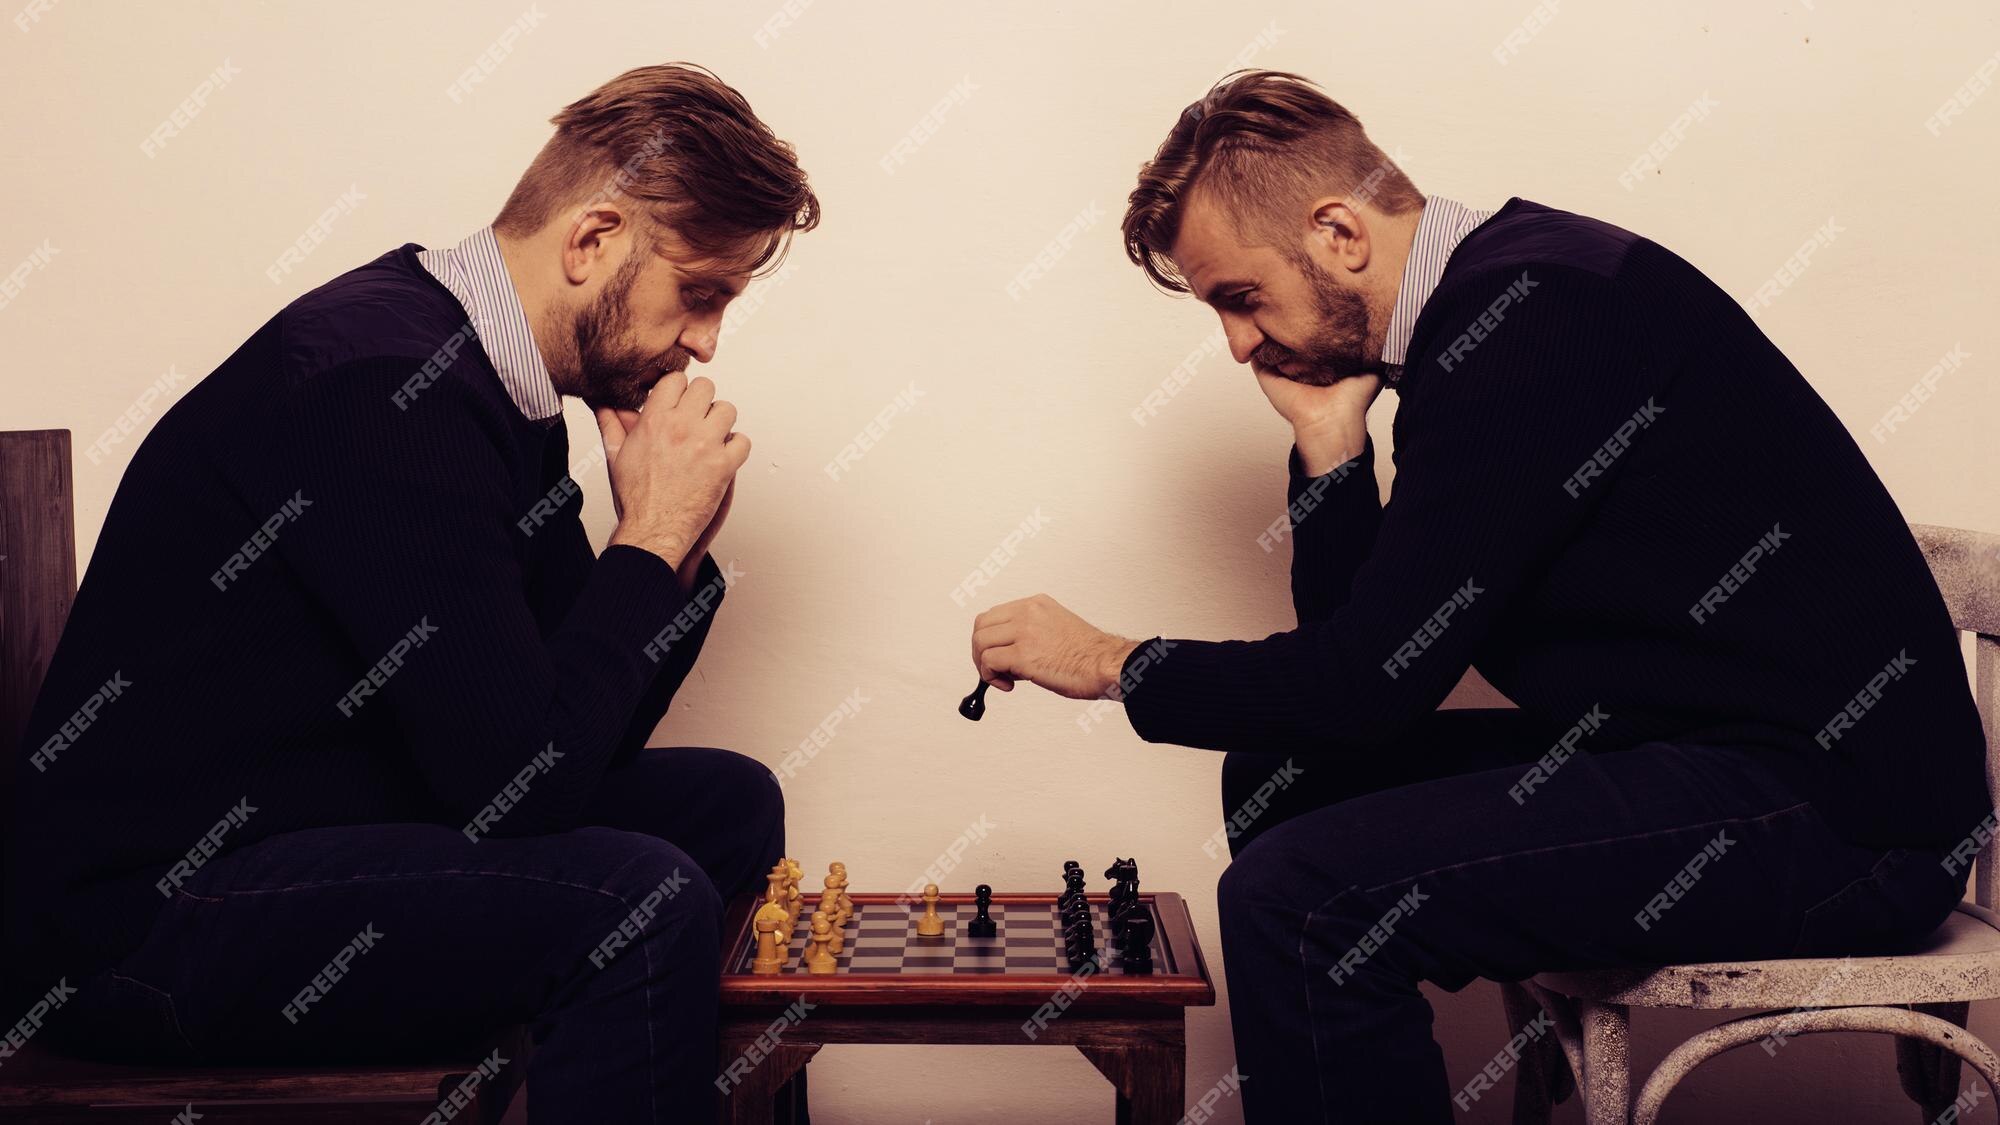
[736,903,1166,981]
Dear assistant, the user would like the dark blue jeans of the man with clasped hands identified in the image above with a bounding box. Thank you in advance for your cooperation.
[50,749,784,1125]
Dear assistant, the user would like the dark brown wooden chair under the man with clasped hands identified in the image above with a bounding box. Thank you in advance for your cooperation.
[0,430,528,1125]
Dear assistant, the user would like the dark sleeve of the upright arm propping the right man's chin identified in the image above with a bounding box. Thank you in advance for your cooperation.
[1284,436,1382,625]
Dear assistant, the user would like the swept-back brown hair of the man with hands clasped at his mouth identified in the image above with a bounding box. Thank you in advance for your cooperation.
[494,62,820,270]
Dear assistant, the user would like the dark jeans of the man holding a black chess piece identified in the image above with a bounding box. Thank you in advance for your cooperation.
[1218,711,1964,1125]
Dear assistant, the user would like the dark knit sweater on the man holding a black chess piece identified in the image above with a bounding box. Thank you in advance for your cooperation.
[1126,198,1988,845]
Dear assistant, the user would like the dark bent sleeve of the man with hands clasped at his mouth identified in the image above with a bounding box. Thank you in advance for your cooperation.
[270,358,686,835]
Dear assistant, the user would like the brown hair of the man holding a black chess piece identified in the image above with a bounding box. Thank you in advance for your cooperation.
[1124,70,1424,292]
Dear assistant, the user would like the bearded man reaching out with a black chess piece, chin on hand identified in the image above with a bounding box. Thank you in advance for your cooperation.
[972,72,1988,1125]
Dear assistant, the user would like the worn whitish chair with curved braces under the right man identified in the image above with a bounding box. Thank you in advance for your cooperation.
[1502,524,2000,1125]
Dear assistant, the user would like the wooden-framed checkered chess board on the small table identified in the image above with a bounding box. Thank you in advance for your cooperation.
[722,891,1214,1005]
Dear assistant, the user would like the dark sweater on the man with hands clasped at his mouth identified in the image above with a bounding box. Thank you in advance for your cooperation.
[6,244,722,989]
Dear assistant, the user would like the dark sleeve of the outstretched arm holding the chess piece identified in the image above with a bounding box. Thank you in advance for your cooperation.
[1126,266,1650,753]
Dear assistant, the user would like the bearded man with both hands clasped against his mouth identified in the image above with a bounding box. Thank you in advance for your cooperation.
[4,66,818,1123]
